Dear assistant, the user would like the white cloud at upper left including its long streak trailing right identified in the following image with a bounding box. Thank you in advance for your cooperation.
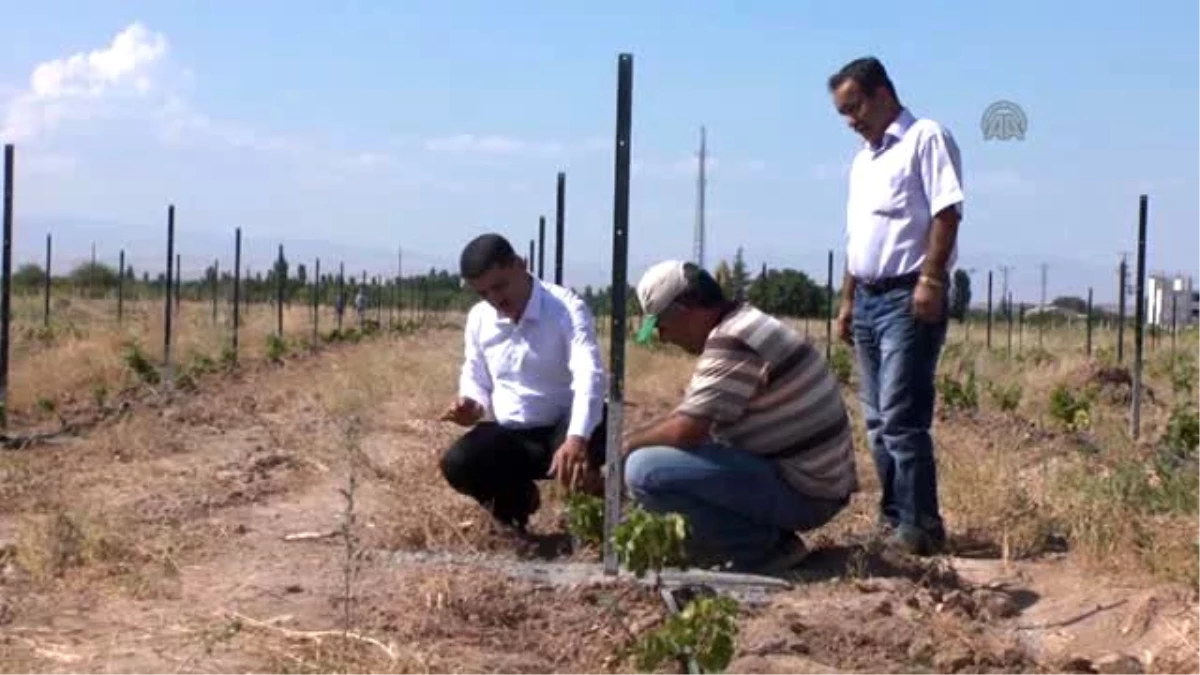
[0,22,612,196]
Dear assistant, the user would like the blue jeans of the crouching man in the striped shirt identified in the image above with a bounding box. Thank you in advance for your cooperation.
[625,443,848,569]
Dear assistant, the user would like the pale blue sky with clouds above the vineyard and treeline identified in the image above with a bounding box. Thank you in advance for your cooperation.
[0,0,1200,301]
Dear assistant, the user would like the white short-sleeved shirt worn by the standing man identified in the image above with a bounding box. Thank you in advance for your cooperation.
[846,109,964,281]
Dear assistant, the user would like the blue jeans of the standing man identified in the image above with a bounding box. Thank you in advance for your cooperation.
[853,281,947,542]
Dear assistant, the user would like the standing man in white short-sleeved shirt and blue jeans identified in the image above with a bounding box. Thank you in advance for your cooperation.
[828,58,964,555]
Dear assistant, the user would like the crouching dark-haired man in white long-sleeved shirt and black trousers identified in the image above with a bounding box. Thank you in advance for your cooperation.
[442,234,606,533]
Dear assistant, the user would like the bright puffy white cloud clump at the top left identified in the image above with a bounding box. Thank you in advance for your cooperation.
[0,22,168,142]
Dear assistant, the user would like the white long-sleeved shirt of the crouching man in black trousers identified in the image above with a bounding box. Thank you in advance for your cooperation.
[458,279,606,438]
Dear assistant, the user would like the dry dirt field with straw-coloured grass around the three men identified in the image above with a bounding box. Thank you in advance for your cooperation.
[0,302,1200,673]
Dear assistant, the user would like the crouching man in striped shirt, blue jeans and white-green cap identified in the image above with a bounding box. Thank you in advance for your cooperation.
[624,261,858,574]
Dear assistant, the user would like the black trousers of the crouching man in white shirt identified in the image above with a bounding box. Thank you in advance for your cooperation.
[442,408,608,527]
